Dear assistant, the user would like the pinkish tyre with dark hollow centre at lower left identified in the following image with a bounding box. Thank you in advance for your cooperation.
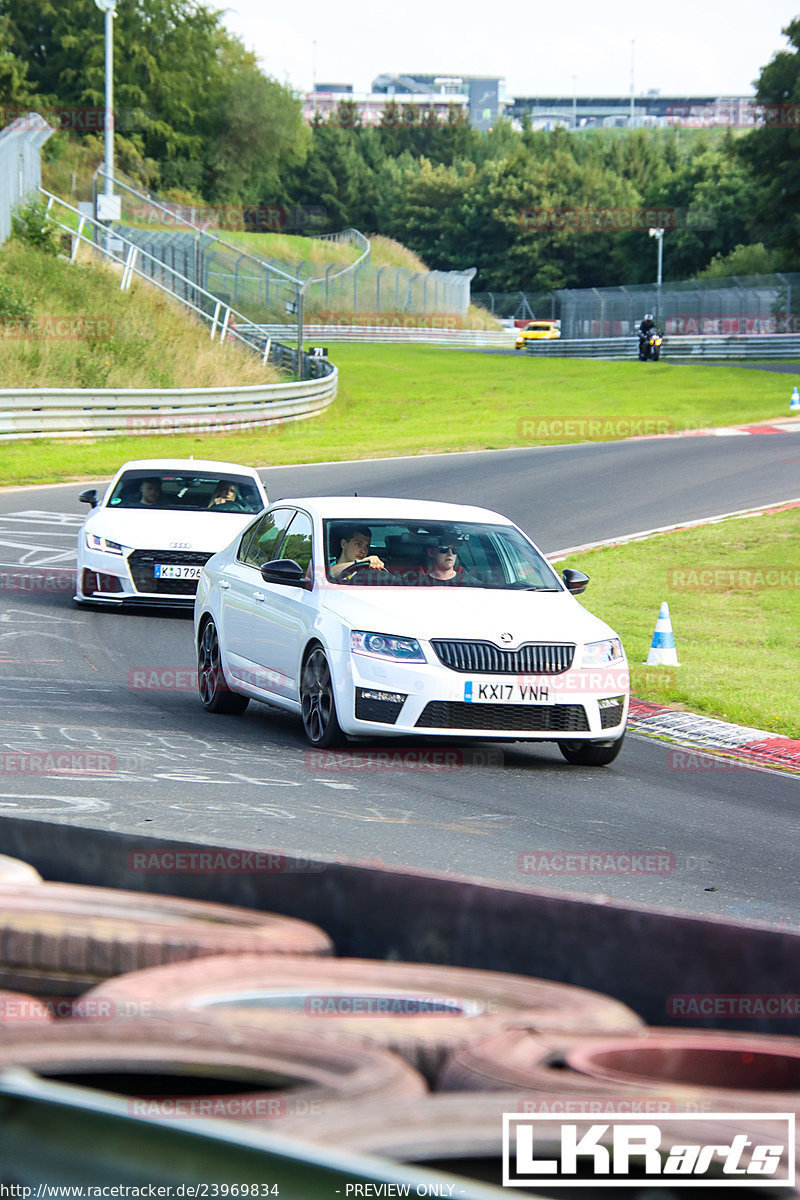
[0,1014,426,1122]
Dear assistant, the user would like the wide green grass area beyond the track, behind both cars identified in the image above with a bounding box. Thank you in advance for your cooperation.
[4,344,790,484]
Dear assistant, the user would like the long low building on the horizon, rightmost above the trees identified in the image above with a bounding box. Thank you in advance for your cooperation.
[506,92,758,130]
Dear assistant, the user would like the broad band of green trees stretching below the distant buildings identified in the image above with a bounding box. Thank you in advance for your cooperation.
[0,0,800,290]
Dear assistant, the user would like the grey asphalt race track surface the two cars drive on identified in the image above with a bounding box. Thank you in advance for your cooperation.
[0,433,800,928]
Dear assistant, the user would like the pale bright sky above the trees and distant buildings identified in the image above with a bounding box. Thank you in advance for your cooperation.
[220,0,800,96]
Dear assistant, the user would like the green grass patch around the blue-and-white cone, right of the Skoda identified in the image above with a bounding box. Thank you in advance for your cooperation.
[558,509,800,738]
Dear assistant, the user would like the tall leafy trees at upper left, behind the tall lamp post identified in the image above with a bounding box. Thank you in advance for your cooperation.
[0,0,308,203]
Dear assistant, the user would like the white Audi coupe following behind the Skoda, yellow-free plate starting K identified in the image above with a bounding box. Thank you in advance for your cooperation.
[74,458,269,607]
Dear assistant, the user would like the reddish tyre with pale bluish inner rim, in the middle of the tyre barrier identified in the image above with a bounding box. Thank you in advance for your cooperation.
[83,955,642,1081]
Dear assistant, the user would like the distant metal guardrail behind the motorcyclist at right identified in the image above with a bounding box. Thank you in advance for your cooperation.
[525,334,800,360]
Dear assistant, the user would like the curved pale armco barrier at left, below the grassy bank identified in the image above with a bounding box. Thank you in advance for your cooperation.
[0,367,338,440]
